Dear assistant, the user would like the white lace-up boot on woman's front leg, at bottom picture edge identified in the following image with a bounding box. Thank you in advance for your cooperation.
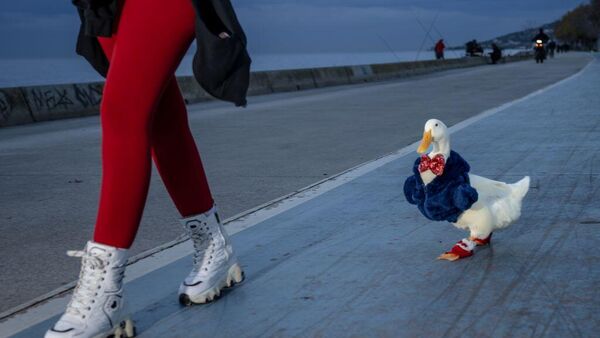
[45,241,135,338]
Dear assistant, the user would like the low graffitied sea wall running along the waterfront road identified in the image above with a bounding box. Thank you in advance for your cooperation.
[0,54,531,127]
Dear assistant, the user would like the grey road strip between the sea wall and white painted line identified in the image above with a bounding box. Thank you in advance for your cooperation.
[0,53,590,312]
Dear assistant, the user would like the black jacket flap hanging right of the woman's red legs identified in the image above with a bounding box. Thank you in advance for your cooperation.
[192,0,252,106]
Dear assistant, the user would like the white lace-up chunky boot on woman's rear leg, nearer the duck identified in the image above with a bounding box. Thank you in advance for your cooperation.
[179,207,244,306]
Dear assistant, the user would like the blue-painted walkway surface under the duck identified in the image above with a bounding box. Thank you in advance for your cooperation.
[0,55,600,337]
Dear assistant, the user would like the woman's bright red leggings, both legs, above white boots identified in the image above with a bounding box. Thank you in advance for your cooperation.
[94,0,213,248]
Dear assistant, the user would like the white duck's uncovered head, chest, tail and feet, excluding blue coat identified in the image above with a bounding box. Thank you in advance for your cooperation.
[417,119,530,261]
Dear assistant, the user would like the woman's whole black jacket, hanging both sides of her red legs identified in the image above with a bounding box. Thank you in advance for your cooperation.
[72,0,251,106]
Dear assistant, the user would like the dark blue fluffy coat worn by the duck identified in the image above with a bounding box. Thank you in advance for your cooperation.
[404,151,478,223]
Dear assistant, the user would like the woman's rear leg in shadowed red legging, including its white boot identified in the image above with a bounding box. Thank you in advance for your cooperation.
[151,76,244,305]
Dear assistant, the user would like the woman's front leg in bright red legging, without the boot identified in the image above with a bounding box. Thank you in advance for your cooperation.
[94,0,195,248]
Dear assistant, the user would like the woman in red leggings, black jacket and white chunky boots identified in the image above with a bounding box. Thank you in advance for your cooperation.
[46,0,251,338]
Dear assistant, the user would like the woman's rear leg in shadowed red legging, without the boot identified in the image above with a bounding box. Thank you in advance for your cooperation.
[151,76,213,217]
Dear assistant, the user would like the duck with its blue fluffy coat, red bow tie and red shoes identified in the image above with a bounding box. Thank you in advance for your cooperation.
[404,119,530,261]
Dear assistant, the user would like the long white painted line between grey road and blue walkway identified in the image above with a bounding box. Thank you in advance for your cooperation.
[0,56,594,337]
